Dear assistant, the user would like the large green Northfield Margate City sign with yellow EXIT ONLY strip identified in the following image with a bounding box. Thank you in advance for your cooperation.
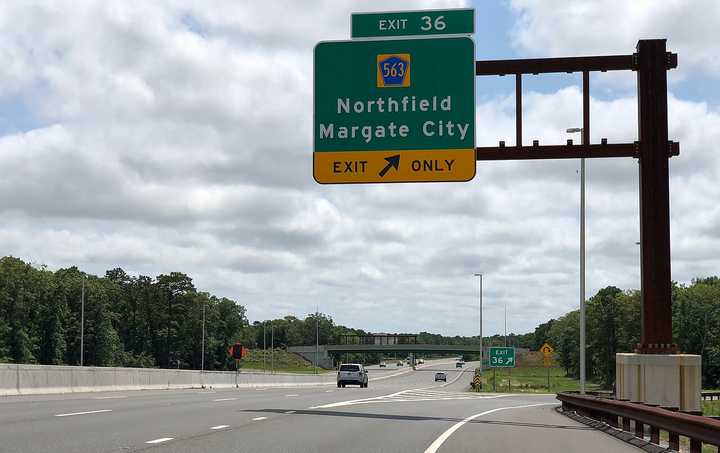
[313,37,476,184]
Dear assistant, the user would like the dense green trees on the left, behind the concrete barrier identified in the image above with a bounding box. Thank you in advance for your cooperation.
[0,256,365,370]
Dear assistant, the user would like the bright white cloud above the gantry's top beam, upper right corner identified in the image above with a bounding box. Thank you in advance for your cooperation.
[510,0,720,76]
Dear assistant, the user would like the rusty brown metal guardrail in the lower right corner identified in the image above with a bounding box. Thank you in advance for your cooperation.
[557,392,720,453]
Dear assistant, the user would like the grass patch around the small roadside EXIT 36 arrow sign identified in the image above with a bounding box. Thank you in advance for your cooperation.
[472,366,599,393]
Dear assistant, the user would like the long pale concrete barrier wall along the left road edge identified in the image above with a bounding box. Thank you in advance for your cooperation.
[0,364,344,396]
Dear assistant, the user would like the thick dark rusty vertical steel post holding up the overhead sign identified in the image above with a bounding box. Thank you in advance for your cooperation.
[636,39,674,354]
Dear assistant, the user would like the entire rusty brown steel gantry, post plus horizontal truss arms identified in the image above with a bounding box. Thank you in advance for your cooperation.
[475,39,680,354]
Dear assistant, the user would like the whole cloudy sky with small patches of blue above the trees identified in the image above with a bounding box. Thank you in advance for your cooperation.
[0,0,720,335]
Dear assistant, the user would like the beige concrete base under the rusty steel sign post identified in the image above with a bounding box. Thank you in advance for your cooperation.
[615,353,702,411]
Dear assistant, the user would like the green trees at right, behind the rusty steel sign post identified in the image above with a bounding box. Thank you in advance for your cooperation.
[524,277,720,388]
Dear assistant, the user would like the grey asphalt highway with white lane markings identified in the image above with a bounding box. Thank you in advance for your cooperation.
[0,362,640,453]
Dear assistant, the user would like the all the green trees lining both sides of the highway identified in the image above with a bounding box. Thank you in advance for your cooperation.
[0,256,720,388]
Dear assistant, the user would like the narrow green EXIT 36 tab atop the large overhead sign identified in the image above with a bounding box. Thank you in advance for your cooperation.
[351,9,475,38]
